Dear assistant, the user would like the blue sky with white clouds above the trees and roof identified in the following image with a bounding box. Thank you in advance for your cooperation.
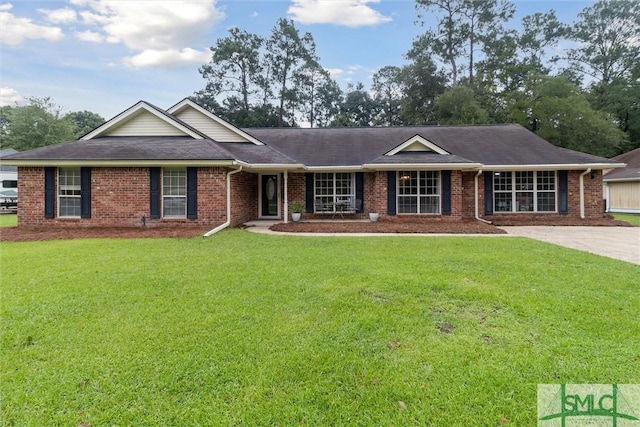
[0,0,594,119]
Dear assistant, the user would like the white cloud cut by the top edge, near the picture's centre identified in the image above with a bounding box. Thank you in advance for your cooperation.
[287,0,391,27]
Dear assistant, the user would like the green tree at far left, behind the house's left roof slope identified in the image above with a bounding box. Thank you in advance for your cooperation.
[0,97,76,151]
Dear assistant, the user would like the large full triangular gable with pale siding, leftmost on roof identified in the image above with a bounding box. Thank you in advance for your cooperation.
[80,101,203,140]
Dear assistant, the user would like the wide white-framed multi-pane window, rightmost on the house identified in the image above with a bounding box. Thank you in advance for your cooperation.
[493,171,556,212]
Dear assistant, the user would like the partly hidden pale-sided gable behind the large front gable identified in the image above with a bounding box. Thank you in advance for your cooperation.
[167,99,264,145]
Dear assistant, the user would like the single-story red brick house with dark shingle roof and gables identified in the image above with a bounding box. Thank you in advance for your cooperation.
[3,99,624,233]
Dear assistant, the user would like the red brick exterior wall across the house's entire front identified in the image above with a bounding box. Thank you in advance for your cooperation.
[18,167,603,228]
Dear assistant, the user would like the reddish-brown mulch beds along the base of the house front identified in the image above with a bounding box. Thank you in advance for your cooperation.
[0,216,630,242]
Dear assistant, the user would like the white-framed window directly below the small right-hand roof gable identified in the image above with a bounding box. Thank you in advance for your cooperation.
[397,171,440,214]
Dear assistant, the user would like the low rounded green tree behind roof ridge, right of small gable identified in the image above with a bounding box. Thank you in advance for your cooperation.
[435,86,489,125]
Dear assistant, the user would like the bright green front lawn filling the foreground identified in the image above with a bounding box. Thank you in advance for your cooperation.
[0,230,640,426]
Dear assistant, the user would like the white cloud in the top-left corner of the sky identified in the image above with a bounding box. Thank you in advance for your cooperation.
[0,3,64,46]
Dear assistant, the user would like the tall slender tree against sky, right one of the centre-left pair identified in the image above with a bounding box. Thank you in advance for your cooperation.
[266,18,318,126]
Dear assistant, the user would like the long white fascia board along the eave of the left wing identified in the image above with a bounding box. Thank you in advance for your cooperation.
[5,160,236,167]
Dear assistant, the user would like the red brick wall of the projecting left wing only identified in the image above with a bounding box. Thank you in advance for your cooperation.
[18,167,257,228]
